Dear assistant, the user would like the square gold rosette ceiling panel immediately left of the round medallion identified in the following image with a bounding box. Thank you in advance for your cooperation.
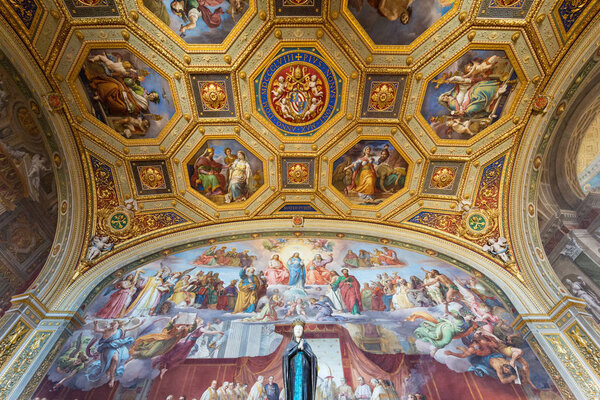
[190,74,235,118]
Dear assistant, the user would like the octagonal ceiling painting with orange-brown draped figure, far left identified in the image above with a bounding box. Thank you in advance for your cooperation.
[76,48,175,139]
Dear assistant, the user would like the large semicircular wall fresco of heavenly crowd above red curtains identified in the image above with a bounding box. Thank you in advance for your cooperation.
[36,237,555,399]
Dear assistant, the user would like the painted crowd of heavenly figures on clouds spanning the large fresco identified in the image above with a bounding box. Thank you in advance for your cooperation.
[76,247,534,387]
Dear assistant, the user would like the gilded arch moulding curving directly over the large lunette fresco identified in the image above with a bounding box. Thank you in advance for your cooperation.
[25,219,564,395]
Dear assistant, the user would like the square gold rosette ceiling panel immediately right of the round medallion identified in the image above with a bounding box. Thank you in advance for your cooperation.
[360,75,406,118]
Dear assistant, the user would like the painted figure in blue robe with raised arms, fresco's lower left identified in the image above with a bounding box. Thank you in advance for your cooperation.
[86,320,142,387]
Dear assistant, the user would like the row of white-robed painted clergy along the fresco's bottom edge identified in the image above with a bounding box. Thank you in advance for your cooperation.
[172,376,426,400]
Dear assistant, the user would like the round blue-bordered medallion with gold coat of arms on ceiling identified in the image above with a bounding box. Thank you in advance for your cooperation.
[256,50,341,136]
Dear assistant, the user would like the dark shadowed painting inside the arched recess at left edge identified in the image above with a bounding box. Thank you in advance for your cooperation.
[0,53,58,314]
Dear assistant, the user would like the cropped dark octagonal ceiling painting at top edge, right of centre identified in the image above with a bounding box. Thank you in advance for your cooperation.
[345,0,454,46]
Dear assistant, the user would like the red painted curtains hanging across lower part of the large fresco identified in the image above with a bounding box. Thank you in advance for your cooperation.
[36,324,527,400]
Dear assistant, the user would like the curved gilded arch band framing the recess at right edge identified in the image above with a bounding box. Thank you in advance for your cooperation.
[508,10,600,305]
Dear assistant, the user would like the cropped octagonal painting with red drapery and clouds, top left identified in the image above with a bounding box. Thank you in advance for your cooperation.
[139,0,249,44]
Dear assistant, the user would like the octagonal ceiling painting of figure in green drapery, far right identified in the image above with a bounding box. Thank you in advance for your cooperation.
[420,49,519,140]
